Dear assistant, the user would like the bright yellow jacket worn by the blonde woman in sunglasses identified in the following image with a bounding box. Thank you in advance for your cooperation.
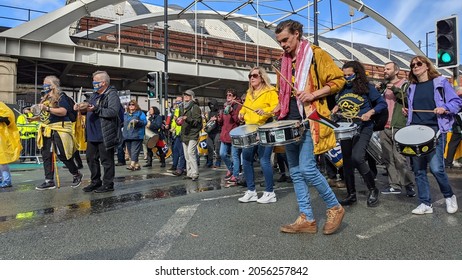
[239,86,279,125]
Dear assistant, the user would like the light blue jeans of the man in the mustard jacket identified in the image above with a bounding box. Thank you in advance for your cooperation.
[286,129,339,221]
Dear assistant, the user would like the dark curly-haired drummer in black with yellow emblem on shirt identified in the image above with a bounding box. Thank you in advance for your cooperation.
[332,61,387,207]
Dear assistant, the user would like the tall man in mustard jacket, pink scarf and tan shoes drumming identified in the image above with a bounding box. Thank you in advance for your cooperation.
[275,20,345,234]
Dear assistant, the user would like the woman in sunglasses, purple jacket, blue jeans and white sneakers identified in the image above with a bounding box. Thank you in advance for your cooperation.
[403,55,462,215]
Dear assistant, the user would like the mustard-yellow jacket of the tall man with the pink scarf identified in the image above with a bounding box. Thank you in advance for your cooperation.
[305,45,345,155]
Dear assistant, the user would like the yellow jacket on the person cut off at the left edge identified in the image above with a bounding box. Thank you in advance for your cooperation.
[0,101,22,164]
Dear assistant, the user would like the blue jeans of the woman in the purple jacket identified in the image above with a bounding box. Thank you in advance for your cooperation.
[411,133,454,205]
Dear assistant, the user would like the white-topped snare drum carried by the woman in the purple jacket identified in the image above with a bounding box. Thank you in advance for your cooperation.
[394,125,436,156]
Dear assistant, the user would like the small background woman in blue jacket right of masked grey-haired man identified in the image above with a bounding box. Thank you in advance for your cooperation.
[123,100,147,171]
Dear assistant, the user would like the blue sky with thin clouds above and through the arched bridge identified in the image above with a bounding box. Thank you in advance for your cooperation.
[0,0,462,57]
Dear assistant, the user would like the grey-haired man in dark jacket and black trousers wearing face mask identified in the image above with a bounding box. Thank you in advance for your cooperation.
[78,71,123,193]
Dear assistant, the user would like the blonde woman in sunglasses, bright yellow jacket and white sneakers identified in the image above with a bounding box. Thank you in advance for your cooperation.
[239,67,278,203]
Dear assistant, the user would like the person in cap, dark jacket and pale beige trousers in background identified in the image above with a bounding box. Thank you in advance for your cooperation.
[176,89,202,181]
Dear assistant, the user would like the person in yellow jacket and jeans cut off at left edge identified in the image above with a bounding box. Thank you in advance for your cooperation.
[0,101,22,188]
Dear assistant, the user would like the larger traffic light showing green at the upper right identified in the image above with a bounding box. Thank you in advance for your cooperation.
[436,16,459,68]
